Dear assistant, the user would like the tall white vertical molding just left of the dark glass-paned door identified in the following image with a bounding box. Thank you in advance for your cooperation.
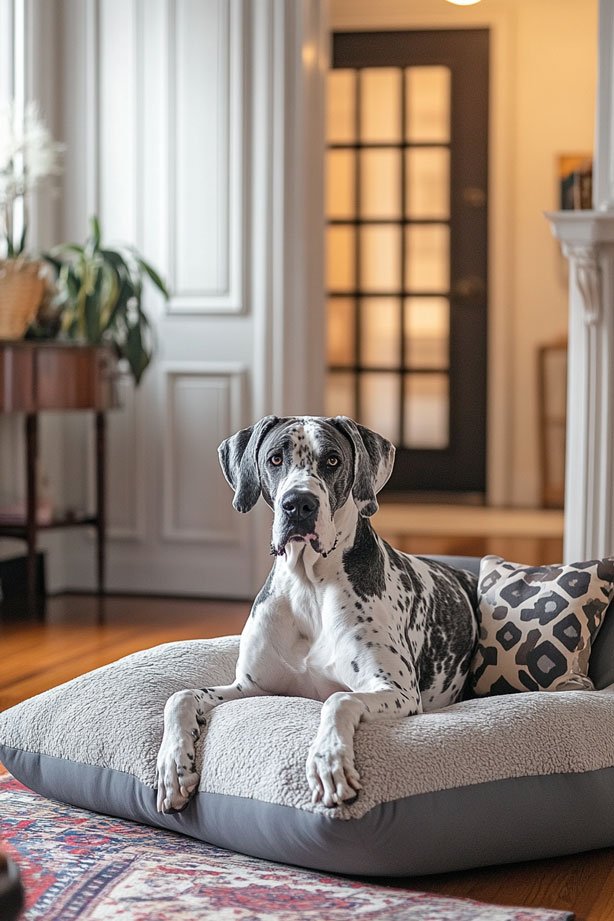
[247,0,329,584]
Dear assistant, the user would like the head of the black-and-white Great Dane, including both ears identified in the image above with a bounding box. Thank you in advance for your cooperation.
[218,416,394,555]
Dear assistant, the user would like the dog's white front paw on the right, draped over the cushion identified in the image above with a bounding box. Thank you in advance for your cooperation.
[306,739,361,807]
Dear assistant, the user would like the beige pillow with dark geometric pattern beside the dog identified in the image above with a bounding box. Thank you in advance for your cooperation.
[469,556,614,697]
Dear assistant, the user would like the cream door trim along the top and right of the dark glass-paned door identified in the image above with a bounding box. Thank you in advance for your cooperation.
[329,0,514,505]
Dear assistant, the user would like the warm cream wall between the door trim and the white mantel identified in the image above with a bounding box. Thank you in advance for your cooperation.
[512,0,597,504]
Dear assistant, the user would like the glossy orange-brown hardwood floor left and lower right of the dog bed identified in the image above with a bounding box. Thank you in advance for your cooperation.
[0,595,614,921]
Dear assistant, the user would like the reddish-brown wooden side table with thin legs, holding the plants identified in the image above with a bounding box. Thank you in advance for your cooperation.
[0,340,119,619]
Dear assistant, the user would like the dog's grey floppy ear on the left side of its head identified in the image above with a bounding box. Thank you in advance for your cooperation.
[217,416,280,512]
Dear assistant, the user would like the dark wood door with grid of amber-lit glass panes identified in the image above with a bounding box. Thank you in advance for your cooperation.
[327,29,489,493]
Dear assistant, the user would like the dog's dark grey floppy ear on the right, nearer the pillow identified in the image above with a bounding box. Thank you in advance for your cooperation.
[330,416,395,518]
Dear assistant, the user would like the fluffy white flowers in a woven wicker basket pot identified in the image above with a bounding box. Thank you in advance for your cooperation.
[0,102,64,339]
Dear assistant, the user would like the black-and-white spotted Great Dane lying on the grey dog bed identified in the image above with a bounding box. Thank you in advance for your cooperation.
[157,416,476,812]
